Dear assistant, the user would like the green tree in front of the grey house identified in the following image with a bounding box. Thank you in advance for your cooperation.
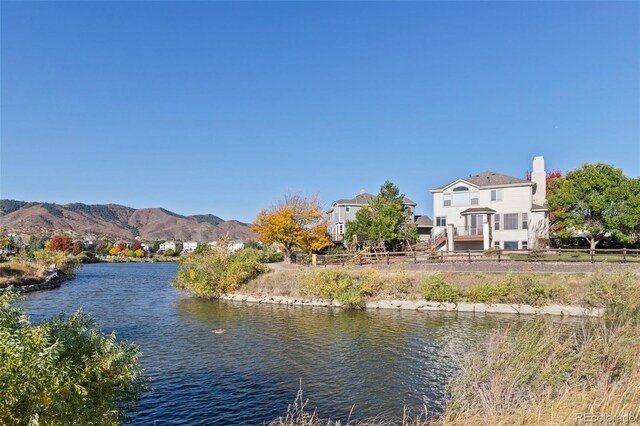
[345,181,418,244]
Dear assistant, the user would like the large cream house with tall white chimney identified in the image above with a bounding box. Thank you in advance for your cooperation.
[431,157,548,251]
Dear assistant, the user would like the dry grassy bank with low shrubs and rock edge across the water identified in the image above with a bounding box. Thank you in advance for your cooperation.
[214,268,640,316]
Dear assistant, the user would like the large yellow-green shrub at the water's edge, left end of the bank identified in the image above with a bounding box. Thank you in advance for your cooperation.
[174,247,269,297]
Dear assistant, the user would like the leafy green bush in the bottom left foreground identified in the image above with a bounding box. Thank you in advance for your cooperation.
[0,293,145,425]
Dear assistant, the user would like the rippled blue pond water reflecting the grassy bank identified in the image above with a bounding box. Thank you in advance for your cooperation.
[23,263,536,425]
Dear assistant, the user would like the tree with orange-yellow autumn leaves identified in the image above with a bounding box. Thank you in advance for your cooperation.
[251,194,333,263]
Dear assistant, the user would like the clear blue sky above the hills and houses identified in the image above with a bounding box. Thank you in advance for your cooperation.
[0,1,640,221]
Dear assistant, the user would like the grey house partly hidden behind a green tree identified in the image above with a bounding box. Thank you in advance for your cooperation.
[325,190,432,243]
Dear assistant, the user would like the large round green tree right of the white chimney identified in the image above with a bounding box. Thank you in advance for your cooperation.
[547,163,627,250]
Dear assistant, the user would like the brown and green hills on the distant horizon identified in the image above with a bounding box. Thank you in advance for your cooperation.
[0,200,254,242]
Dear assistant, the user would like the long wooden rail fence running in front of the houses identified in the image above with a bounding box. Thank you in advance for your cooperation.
[307,247,640,266]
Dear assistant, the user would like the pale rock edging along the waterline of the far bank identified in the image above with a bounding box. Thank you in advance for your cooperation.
[219,294,604,317]
